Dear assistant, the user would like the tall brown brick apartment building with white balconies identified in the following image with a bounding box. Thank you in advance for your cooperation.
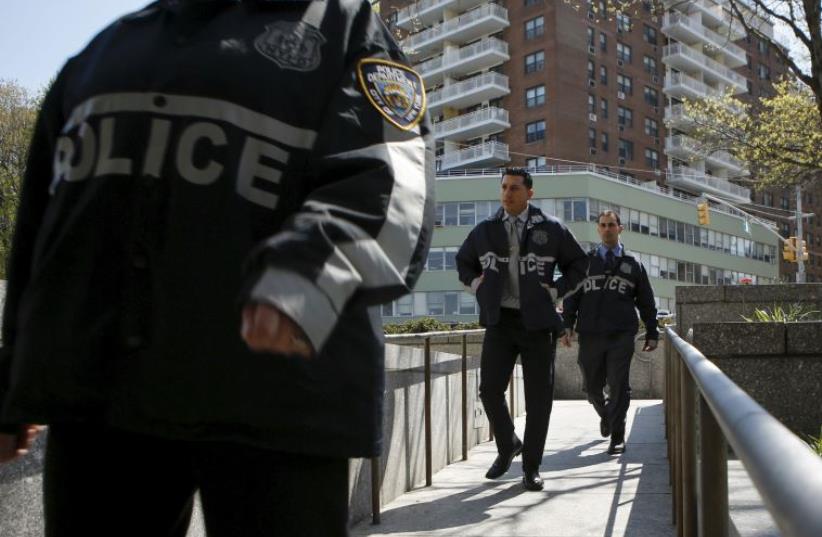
[380,0,822,281]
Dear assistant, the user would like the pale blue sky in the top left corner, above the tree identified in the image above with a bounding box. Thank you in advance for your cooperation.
[0,0,150,92]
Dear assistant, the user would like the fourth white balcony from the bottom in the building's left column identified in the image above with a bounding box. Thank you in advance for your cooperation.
[416,37,510,87]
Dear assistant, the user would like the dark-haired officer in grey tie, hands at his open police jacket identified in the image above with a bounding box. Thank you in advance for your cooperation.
[457,168,586,490]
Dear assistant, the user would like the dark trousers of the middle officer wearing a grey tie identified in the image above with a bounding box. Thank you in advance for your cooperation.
[480,309,556,470]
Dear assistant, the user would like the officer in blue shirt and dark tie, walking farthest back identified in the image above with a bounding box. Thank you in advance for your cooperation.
[562,211,659,454]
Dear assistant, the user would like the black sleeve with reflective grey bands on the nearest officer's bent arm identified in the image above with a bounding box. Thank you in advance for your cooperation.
[241,2,434,356]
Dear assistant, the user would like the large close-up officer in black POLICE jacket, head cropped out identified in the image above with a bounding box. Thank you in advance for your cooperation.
[0,0,434,537]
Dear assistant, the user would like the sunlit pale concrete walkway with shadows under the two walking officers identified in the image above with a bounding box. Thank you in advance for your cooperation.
[352,401,675,537]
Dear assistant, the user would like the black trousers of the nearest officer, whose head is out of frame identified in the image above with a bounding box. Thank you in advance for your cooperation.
[43,425,348,537]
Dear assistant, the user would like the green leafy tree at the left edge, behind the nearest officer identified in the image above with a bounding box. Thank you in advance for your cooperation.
[0,79,41,278]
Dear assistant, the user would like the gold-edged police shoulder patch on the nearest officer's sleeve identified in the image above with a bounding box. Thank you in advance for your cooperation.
[357,58,425,130]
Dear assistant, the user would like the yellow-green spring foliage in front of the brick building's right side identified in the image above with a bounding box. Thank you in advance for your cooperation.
[685,81,822,186]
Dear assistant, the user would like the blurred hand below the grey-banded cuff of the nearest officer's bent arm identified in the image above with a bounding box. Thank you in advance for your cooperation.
[240,304,314,358]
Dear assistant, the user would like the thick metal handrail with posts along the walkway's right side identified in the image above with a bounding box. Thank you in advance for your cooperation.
[665,328,822,537]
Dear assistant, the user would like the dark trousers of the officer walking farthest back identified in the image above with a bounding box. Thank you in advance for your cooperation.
[579,332,634,439]
